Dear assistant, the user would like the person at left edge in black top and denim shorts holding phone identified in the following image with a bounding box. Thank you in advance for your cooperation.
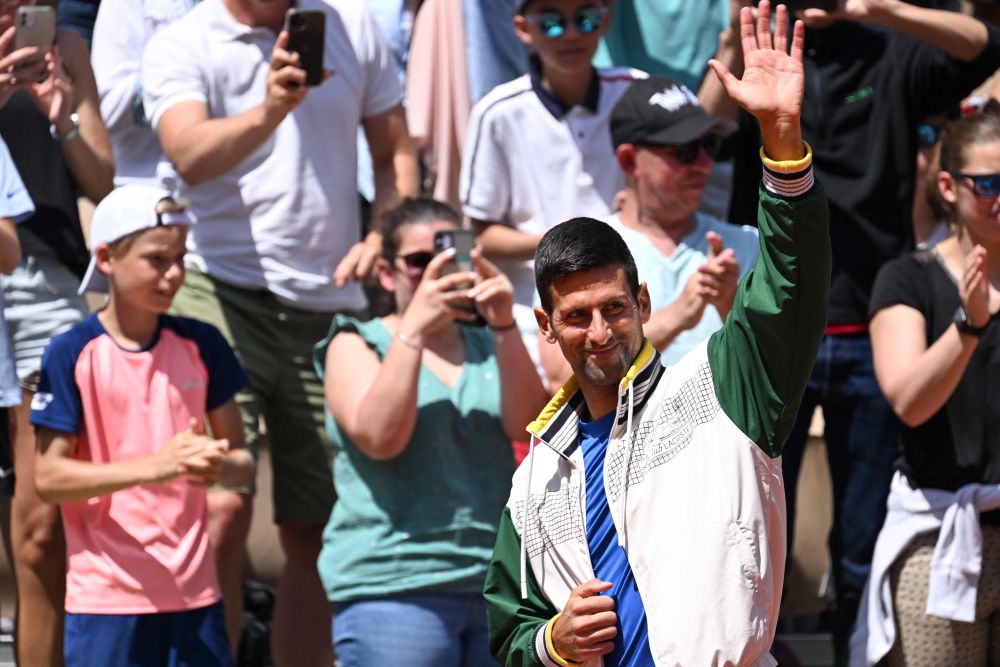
[0,1,114,667]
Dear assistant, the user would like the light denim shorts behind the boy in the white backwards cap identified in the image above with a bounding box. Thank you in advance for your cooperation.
[0,255,89,380]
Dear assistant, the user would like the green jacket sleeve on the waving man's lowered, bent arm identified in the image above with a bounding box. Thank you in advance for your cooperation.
[483,508,559,667]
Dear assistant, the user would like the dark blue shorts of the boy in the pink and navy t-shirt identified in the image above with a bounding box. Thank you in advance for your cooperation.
[63,602,233,667]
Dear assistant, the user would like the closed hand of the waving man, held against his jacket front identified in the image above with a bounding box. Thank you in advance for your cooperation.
[552,579,618,662]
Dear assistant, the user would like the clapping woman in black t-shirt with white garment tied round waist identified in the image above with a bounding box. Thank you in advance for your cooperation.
[852,114,1000,667]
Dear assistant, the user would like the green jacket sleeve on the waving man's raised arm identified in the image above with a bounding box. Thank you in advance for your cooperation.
[708,171,832,457]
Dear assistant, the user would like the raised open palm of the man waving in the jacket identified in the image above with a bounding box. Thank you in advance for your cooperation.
[708,0,805,160]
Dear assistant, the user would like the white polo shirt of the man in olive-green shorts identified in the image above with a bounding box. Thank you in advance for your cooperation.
[142,0,402,311]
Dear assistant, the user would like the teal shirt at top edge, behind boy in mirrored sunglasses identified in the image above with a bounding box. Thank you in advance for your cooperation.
[594,0,729,90]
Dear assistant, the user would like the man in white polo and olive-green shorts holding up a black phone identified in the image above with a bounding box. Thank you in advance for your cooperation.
[142,0,417,665]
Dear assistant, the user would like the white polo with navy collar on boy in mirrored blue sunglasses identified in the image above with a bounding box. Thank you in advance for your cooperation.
[460,67,646,308]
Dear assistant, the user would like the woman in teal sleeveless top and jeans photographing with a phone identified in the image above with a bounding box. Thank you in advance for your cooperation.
[316,199,547,667]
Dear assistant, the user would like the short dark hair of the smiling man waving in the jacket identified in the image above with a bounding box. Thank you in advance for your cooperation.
[535,218,639,315]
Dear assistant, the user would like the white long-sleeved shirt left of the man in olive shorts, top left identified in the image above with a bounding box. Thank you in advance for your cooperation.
[90,0,195,185]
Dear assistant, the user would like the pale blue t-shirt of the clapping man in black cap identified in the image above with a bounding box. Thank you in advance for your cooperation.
[605,213,760,366]
